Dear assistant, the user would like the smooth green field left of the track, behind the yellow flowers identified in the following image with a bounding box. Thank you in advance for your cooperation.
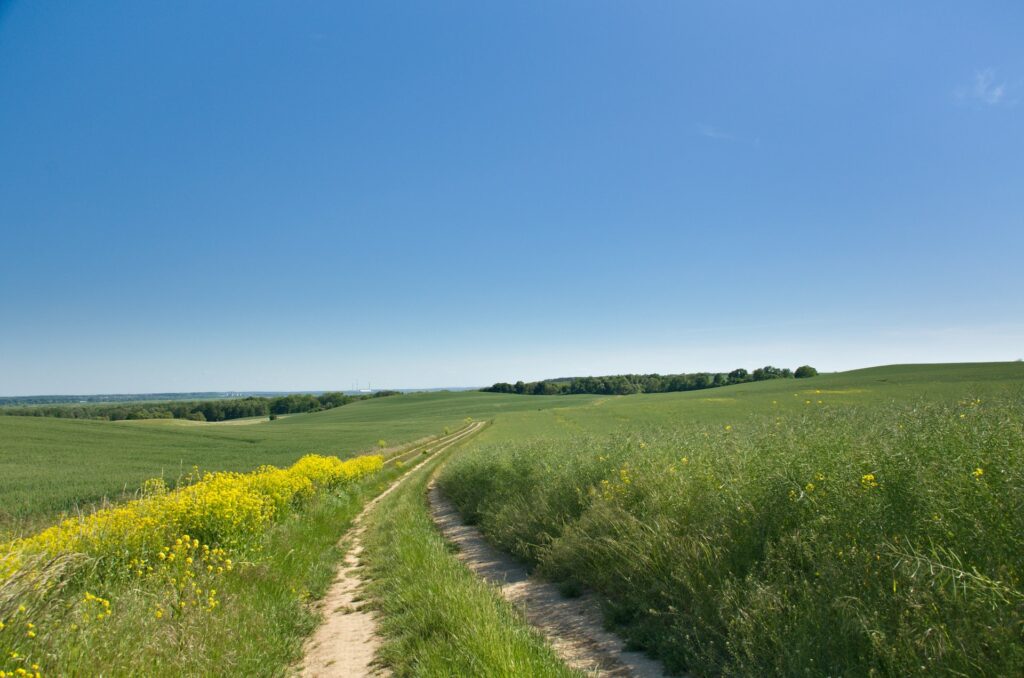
[0,392,589,539]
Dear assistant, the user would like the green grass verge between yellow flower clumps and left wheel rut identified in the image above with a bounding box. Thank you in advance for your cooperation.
[0,458,402,676]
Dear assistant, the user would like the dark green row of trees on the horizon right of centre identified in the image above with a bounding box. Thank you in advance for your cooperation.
[480,365,818,395]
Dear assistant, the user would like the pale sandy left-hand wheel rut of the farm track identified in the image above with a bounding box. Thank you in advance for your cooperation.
[298,422,483,678]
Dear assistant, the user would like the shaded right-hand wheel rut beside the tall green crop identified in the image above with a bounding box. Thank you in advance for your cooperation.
[429,482,665,678]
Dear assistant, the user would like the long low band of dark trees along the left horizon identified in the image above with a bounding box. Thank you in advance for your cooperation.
[0,391,398,421]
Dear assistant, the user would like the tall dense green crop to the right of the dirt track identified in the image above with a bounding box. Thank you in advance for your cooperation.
[440,395,1024,676]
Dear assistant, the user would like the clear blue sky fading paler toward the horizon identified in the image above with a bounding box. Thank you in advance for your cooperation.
[0,0,1024,395]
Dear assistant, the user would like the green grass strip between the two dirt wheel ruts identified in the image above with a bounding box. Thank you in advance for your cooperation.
[364,438,577,676]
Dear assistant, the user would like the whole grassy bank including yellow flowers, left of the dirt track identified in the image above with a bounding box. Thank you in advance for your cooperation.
[0,458,391,676]
